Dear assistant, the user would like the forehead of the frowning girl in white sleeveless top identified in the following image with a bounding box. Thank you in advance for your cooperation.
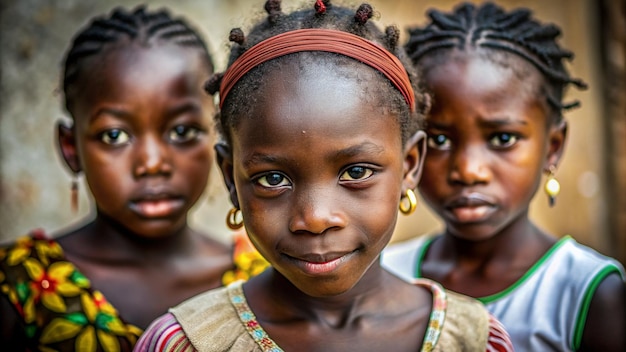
[424,52,549,123]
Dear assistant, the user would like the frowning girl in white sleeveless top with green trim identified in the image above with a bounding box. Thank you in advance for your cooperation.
[383,3,626,351]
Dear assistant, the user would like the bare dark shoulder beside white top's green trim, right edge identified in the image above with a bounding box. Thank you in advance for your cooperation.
[580,273,626,351]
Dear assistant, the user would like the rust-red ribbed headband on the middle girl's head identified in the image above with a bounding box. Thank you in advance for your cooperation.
[220,28,415,111]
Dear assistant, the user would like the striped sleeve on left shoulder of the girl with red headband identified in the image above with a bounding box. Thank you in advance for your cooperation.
[134,313,196,352]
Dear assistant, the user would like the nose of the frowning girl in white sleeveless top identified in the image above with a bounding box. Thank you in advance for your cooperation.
[448,146,491,186]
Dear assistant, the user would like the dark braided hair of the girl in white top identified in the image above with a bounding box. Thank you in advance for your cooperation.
[405,2,587,121]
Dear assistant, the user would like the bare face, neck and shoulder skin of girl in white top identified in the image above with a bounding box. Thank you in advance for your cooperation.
[420,52,626,351]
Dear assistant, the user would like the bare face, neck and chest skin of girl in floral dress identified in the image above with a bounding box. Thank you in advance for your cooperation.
[3,43,233,336]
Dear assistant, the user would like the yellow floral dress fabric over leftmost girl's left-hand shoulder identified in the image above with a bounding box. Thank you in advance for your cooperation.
[0,230,142,352]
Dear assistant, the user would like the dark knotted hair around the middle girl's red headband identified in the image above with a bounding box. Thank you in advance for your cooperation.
[205,0,429,142]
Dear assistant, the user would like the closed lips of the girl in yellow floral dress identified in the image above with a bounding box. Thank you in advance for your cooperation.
[129,193,185,218]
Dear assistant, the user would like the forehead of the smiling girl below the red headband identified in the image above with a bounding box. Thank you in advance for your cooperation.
[231,60,401,153]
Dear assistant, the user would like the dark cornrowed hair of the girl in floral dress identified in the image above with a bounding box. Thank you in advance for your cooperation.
[62,6,213,112]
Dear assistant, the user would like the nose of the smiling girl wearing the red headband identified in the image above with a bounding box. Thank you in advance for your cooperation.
[289,187,347,235]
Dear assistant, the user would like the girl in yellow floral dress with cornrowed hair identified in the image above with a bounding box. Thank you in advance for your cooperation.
[0,7,262,351]
